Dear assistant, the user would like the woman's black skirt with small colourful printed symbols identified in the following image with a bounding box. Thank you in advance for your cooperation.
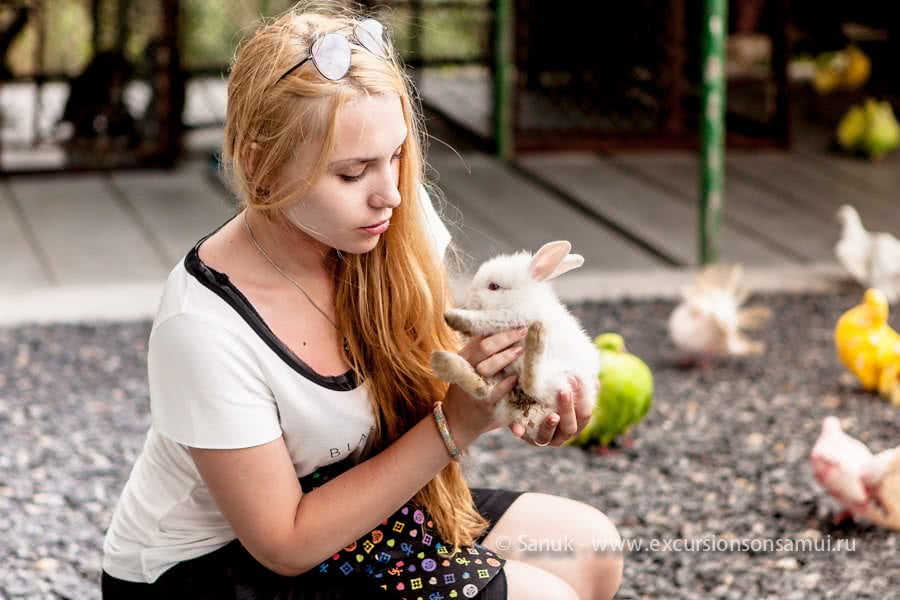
[102,463,521,600]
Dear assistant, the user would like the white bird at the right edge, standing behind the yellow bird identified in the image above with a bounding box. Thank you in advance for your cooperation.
[834,204,900,304]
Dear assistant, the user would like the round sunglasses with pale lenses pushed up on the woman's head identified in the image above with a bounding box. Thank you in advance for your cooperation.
[278,19,387,81]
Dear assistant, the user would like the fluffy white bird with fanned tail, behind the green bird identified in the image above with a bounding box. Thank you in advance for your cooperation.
[669,265,771,363]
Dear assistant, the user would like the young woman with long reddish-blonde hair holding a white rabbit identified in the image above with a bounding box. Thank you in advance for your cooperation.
[103,6,622,600]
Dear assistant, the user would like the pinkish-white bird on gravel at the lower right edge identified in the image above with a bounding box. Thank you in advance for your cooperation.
[809,417,900,529]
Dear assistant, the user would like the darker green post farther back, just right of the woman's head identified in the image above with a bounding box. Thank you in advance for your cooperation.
[494,0,515,160]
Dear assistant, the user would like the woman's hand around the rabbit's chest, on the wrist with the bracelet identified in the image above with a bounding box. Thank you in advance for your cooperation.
[444,327,528,440]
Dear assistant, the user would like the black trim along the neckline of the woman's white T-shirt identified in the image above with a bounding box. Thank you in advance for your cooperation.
[184,232,359,392]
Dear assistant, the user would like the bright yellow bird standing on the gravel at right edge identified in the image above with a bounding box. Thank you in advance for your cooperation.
[834,288,900,405]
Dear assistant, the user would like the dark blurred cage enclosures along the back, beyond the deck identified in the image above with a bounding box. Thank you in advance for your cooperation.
[0,0,900,173]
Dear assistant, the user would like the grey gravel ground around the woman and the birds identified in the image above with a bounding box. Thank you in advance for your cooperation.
[0,290,900,599]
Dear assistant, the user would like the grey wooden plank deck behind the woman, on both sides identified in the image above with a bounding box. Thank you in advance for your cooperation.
[0,108,900,294]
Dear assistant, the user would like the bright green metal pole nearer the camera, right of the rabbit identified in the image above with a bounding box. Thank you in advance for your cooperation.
[700,0,728,265]
